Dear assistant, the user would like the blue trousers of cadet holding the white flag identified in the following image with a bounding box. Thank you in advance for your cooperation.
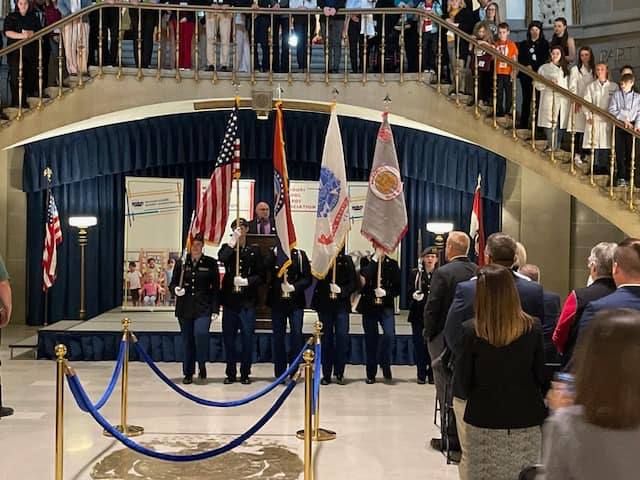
[318,308,349,379]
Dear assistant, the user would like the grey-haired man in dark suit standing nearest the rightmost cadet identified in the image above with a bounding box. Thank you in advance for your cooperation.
[424,231,478,451]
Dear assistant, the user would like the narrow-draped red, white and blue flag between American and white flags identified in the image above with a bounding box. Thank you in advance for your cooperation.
[273,101,296,277]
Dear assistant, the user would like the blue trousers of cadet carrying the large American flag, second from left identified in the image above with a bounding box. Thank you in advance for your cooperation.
[222,307,256,379]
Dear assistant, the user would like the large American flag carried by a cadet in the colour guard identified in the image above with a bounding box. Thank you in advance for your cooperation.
[191,105,240,245]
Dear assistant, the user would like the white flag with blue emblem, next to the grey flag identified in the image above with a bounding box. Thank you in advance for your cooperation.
[311,107,351,279]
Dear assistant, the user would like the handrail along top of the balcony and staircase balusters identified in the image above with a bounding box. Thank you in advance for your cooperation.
[0,3,640,138]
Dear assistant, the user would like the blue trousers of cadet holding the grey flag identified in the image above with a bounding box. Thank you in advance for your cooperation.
[362,308,396,378]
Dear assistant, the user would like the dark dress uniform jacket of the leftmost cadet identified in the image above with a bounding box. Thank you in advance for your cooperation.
[169,255,220,319]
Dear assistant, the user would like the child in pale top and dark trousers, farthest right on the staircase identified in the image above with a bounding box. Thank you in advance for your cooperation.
[609,73,640,187]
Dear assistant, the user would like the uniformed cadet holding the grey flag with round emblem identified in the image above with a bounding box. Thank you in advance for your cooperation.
[358,249,400,384]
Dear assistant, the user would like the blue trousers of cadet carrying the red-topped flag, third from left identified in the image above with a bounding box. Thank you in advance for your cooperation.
[271,308,304,377]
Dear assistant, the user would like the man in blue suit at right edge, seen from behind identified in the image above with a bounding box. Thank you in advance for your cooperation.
[580,238,640,333]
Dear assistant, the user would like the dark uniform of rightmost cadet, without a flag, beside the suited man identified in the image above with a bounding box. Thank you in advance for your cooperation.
[407,268,433,383]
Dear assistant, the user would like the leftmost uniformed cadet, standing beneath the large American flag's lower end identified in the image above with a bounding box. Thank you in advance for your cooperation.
[170,234,220,384]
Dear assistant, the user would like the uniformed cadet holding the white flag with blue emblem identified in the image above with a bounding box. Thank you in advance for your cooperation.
[312,252,357,385]
